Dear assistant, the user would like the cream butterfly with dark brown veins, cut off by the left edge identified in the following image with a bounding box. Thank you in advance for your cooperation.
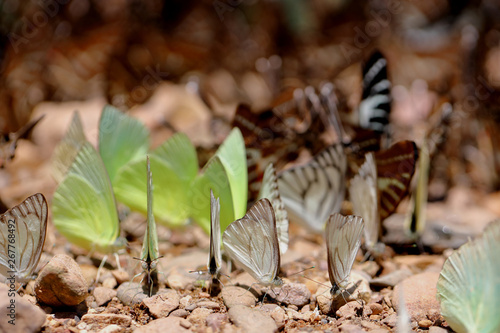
[0,193,48,283]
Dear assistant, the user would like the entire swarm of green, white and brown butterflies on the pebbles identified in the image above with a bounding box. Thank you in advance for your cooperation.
[0,52,500,332]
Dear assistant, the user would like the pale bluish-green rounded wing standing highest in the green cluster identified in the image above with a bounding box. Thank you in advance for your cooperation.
[99,105,149,184]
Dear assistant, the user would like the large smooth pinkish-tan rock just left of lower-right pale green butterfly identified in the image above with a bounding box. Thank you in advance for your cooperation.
[392,272,440,322]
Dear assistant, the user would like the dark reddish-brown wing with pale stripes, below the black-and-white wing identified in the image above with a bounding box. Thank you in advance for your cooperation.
[375,141,418,221]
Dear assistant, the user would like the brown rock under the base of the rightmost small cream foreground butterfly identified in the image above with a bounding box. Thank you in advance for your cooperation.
[315,271,371,314]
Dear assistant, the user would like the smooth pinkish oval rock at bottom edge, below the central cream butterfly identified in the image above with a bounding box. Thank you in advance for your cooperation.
[228,305,278,333]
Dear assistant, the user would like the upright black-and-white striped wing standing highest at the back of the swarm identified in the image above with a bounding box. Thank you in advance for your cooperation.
[358,51,391,133]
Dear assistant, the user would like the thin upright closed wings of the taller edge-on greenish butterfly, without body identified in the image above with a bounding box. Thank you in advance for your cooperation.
[141,157,158,266]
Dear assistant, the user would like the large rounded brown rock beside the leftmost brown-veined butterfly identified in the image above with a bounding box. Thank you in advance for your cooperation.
[35,254,88,306]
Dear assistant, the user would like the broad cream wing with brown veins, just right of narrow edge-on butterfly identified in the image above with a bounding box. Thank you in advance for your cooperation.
[222,198,280,285]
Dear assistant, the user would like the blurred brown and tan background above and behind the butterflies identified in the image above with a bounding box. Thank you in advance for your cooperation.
[0,0,500,239]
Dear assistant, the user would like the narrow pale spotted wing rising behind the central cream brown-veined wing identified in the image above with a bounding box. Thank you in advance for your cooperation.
[259,163,288,254]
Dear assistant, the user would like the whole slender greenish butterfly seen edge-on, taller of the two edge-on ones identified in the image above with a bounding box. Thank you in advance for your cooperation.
[141,156,159,297]
